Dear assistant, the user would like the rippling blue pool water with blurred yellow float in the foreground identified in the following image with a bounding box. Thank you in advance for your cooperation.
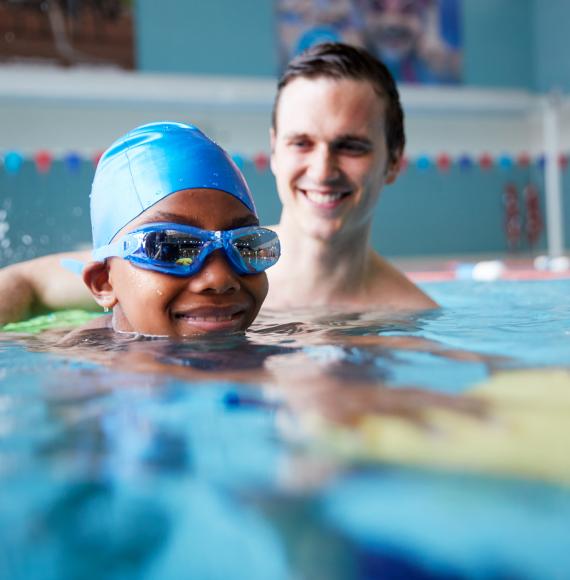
[0,280,570,579]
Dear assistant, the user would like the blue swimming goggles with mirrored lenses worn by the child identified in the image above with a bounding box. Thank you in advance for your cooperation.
[92,223,280,276]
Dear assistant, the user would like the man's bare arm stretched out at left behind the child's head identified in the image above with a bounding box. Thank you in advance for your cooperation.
[0,251,99,325]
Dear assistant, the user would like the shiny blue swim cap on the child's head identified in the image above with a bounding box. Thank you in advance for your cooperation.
[91,122,257,248]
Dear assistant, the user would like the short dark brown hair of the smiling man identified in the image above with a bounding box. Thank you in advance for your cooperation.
[271,42,406,162]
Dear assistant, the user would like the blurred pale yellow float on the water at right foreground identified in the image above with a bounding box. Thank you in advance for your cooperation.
[307,369,570,485]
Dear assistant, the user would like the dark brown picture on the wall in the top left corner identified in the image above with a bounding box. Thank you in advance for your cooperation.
[0,0,134,69]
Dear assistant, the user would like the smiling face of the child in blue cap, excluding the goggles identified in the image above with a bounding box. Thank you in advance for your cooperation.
[86,189,267,337]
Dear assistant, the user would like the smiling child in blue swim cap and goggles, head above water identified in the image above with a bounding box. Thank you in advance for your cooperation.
[75,123,280,337]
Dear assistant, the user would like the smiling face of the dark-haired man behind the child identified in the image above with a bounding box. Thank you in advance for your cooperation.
[271,77,397,240]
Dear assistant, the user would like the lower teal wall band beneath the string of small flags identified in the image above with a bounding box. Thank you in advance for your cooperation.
[0,160,556,265]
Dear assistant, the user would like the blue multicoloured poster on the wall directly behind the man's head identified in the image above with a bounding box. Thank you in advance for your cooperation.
[277,0,462,84]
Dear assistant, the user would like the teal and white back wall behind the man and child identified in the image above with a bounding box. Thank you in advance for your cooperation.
[0,0,570,264]
